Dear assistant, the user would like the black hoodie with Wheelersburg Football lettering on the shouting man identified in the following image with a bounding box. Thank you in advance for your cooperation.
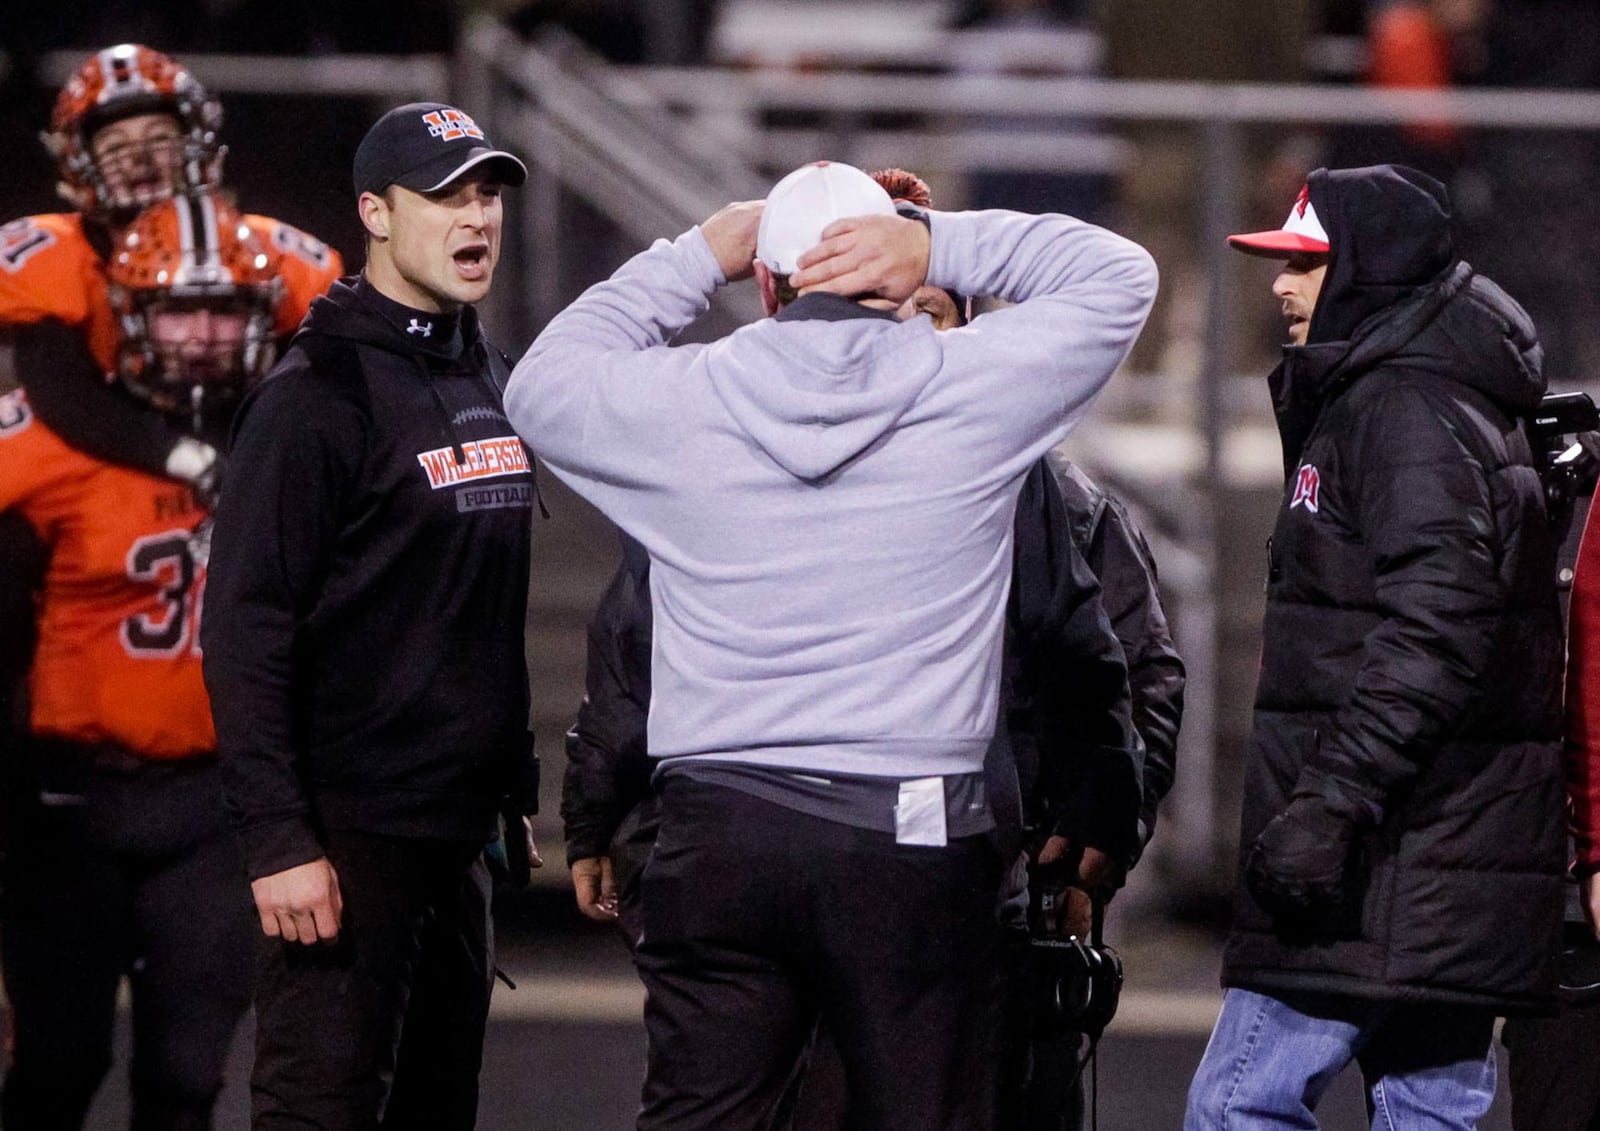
[202,280,536,878]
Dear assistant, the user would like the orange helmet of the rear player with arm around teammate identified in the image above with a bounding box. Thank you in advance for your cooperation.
[40,43,227,221]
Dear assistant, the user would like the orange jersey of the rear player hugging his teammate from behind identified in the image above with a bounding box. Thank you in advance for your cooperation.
[0,213,344,359]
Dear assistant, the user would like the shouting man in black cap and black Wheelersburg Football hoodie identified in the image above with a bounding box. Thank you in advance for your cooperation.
[202,102,538,1131]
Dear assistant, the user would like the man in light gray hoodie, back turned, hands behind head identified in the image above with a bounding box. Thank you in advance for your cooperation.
[506,163,1155,1131]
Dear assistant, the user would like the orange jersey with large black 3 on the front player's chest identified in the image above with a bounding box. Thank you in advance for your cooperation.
[0,390,216,758]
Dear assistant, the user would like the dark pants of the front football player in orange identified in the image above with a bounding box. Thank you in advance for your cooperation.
[0,744,253,1131]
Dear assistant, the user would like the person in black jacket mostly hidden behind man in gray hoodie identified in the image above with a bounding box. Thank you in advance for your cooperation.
[562,270,1184,1131]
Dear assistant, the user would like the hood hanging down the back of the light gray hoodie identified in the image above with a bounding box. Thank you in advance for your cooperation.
[706,294,944,480]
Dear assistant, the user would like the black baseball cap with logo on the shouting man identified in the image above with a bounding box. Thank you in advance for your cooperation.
[355,102,528,195]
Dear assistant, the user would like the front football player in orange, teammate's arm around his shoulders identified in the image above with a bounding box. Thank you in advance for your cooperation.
[0,194,283,1131]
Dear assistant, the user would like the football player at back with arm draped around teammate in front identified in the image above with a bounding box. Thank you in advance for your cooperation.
[0,43,344,490]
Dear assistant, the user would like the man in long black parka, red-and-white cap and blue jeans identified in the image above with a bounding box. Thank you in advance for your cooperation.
[1186,166,1565,1131]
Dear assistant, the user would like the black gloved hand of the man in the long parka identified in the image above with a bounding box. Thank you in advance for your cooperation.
[1245,793,1357,918]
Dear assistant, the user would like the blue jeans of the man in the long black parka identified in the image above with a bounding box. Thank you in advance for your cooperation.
[1184,989,1494,1131]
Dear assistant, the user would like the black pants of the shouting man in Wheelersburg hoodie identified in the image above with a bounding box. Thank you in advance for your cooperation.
[251,830,488,1131]
